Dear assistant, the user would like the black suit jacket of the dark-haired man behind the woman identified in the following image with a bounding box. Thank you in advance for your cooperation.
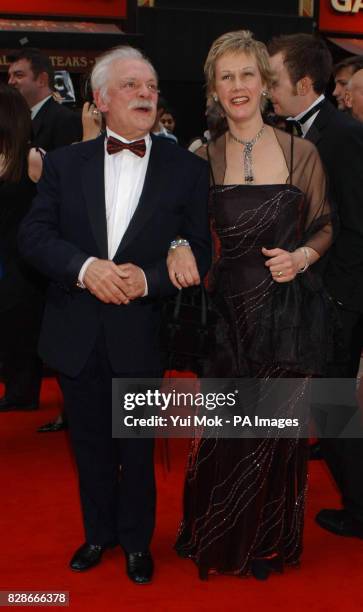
[306,100,363,312]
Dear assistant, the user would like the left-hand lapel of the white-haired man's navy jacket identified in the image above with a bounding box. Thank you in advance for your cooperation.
[82,136,108,259]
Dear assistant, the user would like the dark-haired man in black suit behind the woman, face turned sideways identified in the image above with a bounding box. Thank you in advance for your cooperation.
[269,34,363,537]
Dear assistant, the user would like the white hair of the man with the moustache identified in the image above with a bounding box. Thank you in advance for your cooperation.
[91,45,158,100]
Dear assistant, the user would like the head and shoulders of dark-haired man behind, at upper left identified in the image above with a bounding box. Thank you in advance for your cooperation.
[8,48,82,153]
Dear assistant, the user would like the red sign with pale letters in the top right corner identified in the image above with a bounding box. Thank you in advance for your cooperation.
[319,0,363,34]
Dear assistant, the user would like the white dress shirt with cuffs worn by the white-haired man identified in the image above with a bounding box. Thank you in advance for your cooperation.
[78,128,152,295]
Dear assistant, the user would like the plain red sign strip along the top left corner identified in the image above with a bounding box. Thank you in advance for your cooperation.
[0,0,127,19]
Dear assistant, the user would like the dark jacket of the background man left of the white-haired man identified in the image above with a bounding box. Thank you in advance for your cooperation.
[32,98,82,152]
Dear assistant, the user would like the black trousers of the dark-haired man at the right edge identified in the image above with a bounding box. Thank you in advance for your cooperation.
[320,308,363,521]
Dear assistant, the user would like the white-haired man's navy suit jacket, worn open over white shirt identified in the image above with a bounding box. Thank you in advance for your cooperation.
[19,136,211,377]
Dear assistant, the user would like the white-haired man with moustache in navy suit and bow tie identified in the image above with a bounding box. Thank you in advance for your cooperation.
[19,47,210,584]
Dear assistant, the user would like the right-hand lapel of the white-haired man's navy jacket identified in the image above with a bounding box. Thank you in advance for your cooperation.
[114,135,167,259]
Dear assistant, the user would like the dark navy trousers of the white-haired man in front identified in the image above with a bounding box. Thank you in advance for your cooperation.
[60,333,160,552]
